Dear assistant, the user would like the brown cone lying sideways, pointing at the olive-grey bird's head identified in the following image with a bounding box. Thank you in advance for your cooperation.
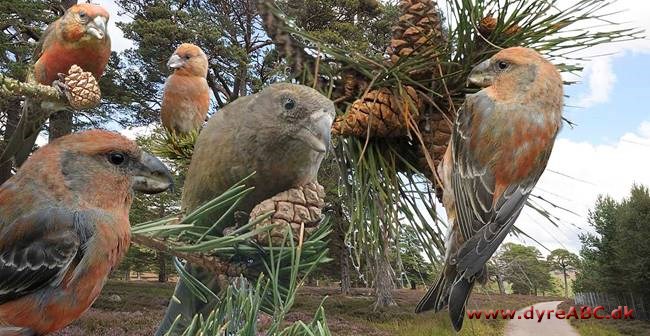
[332,86,422,138]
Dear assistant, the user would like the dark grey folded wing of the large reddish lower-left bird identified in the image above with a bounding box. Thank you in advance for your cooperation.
[0,208,92,304]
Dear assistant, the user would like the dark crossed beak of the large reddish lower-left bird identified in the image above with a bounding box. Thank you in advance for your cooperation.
[133,152,174,194]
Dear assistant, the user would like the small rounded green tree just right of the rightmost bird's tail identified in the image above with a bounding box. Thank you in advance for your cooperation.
[493,243,553,295]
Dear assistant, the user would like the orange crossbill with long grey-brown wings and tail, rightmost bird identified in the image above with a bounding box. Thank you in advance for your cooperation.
[416,47,563,331]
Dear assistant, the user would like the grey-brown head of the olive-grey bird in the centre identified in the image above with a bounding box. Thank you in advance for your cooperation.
[255,83,335,154]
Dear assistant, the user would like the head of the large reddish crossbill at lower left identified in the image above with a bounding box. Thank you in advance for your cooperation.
[18,130,173,207]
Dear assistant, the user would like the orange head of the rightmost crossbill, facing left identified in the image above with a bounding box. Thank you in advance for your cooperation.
[467,47,561,90]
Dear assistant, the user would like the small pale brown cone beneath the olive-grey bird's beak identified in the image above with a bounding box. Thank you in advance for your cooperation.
[250,182,325,246]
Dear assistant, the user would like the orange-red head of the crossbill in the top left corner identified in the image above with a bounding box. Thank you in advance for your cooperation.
[62,3,109,41]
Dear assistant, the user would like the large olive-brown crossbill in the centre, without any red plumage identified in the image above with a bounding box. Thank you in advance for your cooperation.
[156,83,335,335]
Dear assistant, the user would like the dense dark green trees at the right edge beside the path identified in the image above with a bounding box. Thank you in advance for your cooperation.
[574,185,650,298]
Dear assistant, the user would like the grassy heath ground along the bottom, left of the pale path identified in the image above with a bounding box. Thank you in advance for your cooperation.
[53,281,560,336]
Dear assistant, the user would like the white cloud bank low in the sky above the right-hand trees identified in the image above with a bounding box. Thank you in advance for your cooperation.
[508,122,650,252]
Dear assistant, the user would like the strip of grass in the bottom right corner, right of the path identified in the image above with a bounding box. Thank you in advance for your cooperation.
[558,300,650,336]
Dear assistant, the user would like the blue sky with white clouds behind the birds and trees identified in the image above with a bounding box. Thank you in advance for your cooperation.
[95,0,650,254]
